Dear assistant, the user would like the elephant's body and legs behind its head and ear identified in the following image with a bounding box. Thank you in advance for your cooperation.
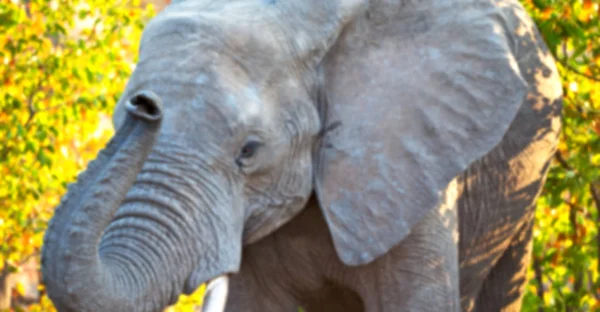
[227,1,562,312]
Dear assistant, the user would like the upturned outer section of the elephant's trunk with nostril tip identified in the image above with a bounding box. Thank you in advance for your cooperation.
[42,93,162,311]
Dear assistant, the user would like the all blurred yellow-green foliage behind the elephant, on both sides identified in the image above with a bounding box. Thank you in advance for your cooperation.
[0,0,600,311]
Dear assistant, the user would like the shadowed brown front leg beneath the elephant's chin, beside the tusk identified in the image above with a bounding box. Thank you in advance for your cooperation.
[227,198,338,312]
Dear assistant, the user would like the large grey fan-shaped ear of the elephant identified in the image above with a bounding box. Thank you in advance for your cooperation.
[315,1,527,265]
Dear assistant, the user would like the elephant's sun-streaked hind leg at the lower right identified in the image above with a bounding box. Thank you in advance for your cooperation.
[475,213,533,312]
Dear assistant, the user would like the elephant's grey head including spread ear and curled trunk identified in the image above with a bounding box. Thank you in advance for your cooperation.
[42,0,526,311]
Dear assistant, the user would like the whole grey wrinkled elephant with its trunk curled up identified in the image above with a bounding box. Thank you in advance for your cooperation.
[42,0,561,311]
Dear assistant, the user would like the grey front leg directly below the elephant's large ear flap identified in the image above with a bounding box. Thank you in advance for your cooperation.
[353,181,460,312]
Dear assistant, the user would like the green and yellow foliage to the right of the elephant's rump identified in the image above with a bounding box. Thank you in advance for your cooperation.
[523,0,600,311]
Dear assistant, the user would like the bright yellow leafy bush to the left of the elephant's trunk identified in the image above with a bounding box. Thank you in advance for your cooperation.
[0,0,202,311]
